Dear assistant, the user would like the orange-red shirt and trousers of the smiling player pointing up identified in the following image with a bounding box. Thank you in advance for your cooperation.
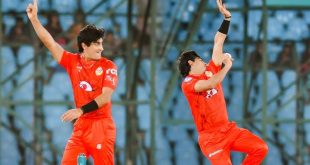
[59,51,118,165]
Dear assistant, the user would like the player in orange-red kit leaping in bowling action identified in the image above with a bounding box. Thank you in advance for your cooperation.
[178,0,268,165]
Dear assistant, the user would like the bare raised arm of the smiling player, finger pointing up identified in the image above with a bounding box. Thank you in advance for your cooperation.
[26,0,64,62]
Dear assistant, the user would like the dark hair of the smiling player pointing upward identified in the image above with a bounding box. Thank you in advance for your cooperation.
[77,25,104,53]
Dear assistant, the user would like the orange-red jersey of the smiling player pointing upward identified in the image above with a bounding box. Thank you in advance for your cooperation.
[59,51,118,118]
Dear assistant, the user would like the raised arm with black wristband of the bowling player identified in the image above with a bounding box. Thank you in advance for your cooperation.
[212,0,231,65]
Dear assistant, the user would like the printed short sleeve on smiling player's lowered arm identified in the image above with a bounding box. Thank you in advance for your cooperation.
[102,62,118,90]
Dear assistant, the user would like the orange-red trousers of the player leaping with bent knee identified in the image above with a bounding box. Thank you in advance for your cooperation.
[198,123,268,165]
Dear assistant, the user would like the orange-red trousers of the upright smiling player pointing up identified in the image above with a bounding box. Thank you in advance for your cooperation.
[61,118,116,165]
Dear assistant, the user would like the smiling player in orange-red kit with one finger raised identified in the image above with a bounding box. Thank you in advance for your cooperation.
[27,0,118,165]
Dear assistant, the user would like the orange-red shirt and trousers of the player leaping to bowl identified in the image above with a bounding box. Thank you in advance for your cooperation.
[182,60,268,165]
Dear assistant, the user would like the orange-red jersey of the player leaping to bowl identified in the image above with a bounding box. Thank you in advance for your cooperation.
[182,61,229,132]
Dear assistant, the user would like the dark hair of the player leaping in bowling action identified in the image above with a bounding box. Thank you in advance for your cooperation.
[178,50,201,77]
